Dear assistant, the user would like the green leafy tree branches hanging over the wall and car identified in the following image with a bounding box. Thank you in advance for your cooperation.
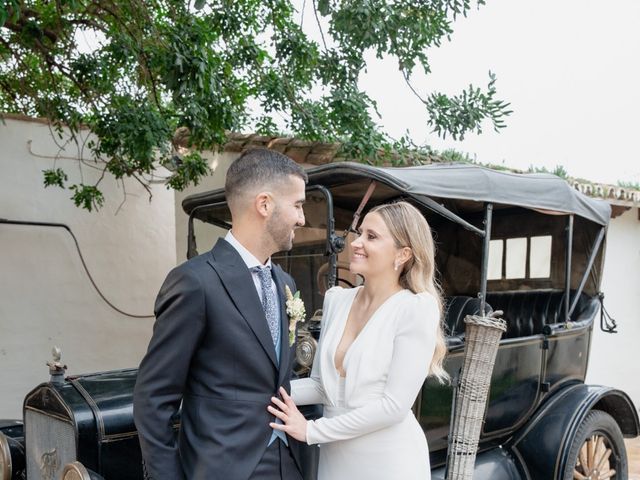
[0,0,510,210]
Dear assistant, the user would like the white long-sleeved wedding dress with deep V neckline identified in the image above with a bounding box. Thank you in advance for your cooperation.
[291,287,440,480]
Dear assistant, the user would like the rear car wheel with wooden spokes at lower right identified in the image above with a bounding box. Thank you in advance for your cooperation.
[562,410,627,480]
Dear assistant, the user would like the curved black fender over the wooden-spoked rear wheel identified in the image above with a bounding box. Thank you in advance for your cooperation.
[508,384,640,479]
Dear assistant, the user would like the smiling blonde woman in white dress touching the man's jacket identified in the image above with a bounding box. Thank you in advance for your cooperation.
[268,202,448,480]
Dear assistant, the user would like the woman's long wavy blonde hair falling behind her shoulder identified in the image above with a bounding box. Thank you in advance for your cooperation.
[370,202,449,383]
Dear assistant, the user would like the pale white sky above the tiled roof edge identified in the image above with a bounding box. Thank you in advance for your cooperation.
[361,0,640,184]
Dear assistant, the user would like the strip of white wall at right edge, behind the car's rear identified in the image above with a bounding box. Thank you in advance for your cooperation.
[587,208,640,408]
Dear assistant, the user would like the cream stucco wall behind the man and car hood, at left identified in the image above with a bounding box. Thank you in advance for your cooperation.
[0,115,176,418]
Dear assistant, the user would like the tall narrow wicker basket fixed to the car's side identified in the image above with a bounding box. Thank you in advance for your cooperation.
[447,312,507,480]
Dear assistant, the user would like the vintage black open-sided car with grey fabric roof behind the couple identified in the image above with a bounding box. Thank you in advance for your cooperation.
[0,162,640,480]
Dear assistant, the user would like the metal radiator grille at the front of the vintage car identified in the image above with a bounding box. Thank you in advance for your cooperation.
[24,410,76,480]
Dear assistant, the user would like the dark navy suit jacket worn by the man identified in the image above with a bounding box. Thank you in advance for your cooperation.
[134,239,299,480]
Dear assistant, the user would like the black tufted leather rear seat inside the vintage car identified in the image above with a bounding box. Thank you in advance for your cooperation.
[487,290,596,338]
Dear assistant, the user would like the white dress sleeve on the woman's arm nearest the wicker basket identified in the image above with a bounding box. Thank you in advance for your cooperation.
[307,293,440,445]
